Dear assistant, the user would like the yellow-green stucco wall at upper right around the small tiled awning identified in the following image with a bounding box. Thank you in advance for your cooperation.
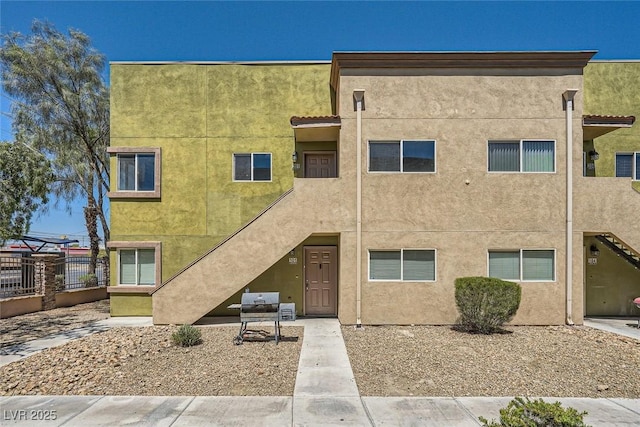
[584,61,640,176]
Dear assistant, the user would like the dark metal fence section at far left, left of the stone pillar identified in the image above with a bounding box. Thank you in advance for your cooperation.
[0,253,36,298]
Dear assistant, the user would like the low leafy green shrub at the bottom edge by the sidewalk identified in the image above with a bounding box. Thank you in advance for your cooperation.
[478,397,587,427]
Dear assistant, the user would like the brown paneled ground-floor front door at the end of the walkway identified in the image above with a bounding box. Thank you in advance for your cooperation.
[304,246,338,316]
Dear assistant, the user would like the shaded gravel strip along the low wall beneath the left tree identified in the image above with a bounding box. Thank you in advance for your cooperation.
[0,299,109,348]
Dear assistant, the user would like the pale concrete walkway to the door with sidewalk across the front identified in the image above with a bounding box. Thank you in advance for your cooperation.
[0,318,640,426]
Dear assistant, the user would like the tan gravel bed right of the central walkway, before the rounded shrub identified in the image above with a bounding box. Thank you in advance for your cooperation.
[342,326,640,398]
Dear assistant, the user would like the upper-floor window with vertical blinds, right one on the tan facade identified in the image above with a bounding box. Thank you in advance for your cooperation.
[487,139,556,172]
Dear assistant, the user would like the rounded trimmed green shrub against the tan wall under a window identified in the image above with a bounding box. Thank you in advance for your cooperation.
[455,277,521,334]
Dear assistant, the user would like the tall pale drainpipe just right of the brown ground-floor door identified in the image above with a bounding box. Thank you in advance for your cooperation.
[353,89,364,328]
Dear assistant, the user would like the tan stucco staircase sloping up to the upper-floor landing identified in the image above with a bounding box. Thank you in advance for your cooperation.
[152,178,355,324]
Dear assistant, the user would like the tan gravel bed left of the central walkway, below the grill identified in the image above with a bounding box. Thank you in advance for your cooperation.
[0,326,303,396]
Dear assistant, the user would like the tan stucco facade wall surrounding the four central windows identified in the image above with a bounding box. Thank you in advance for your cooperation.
[338,70,582,324]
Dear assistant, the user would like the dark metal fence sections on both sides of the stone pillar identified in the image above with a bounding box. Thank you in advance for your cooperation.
[0,252,108,298]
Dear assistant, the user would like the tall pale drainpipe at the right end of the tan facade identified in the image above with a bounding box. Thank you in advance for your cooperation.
[562,89,578,325]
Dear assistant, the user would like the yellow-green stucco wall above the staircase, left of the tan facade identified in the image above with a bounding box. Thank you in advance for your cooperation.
[110,63,331,315]
